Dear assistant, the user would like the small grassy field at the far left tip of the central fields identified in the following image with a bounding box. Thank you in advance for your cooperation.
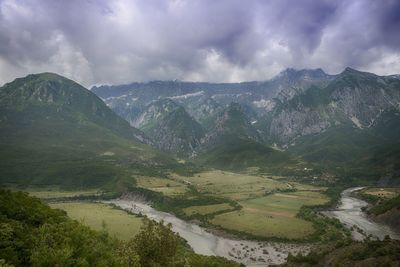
[136,176,187,196]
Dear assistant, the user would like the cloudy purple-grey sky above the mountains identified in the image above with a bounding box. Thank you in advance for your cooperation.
[0,0,400,87]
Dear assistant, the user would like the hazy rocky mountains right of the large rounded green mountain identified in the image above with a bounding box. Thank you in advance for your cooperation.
[91,68,400,183]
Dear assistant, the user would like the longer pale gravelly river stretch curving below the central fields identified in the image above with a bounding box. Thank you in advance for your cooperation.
[104,198,310,266]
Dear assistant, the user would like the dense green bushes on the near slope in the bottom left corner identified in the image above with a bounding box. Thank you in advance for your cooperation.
[0,189,236,266]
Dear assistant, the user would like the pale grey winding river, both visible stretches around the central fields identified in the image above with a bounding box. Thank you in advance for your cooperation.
[105,187,400,266]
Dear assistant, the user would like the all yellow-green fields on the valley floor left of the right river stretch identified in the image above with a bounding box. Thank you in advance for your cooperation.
[22,170,329,240]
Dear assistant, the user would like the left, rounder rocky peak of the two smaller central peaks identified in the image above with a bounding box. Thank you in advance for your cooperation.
[133,98,204,156]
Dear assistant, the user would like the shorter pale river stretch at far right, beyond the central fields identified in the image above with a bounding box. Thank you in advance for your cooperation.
[324,187,400,240]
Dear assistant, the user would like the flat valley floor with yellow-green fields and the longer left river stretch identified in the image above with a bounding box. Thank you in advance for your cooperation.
[13,175,399,266]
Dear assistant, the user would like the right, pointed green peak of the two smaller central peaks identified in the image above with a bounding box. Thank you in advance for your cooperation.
[193,103,305,174]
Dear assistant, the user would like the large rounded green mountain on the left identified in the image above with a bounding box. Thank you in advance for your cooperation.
[0,73,174,187]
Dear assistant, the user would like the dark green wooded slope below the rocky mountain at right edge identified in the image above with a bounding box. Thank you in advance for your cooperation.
[289,120,400,184]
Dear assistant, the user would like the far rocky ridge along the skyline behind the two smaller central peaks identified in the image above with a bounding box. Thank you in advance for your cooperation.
[92,68,400,183]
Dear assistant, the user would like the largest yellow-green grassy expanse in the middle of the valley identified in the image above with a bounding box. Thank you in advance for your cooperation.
[171,170,329,240]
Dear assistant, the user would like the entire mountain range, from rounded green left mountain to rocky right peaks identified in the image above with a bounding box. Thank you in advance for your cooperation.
[0,68,400,189]
